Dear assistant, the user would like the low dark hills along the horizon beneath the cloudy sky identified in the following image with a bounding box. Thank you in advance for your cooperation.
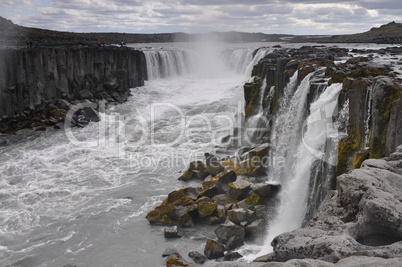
[0,17,402,46]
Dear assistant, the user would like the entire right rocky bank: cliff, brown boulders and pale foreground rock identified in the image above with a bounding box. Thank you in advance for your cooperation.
[147,47,402,266]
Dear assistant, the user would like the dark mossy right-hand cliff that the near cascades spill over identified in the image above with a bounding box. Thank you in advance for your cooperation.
[244,47,402,175]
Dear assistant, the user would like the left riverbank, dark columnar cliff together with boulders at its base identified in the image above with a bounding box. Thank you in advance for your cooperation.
[0,47,147,134]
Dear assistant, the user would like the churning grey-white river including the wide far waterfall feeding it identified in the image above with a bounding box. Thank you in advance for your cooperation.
[0,41,272,266]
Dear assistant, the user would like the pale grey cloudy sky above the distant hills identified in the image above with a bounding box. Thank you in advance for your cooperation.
[0,0,402,34]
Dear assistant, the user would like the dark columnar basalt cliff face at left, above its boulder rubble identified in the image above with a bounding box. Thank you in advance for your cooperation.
[0,47,147,116]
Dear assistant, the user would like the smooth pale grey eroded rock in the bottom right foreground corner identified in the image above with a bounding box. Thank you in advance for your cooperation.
[266,146,402,266]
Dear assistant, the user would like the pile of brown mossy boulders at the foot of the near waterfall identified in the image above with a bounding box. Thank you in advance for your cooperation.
[147,147,280,262]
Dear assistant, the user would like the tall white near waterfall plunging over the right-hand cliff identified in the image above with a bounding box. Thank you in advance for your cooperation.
[240,73,342,260]
